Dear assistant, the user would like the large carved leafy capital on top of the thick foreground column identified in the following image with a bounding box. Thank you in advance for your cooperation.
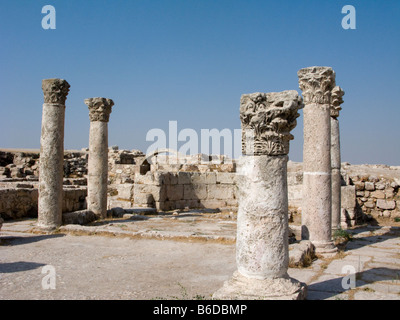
[240,90,303,156]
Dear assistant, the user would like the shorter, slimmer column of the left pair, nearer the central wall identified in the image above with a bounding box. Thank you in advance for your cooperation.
[85,98,114,219]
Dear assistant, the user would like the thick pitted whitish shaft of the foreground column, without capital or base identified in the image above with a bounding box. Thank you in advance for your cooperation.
[236,155,289,279]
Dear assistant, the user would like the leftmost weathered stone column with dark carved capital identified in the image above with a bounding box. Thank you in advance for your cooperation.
[37,79,70,231]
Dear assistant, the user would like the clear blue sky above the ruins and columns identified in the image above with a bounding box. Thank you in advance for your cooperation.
[0,0,400,165]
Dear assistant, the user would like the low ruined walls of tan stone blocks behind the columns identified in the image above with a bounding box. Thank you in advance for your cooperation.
[0,147,400,226]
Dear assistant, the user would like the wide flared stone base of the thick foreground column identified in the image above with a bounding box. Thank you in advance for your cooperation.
[212,271,307,300]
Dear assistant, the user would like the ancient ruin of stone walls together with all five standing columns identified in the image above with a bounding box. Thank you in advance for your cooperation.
[0,67,400,299]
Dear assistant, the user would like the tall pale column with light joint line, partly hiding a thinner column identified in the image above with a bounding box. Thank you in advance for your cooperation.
[298,67,336,253]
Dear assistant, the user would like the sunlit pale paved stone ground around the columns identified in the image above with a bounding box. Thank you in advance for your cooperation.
[0,214,400,300]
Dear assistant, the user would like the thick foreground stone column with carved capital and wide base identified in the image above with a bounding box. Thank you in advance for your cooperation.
[213,91,306,300]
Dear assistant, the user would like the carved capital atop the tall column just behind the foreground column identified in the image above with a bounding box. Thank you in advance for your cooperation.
[297,67,335,104]
